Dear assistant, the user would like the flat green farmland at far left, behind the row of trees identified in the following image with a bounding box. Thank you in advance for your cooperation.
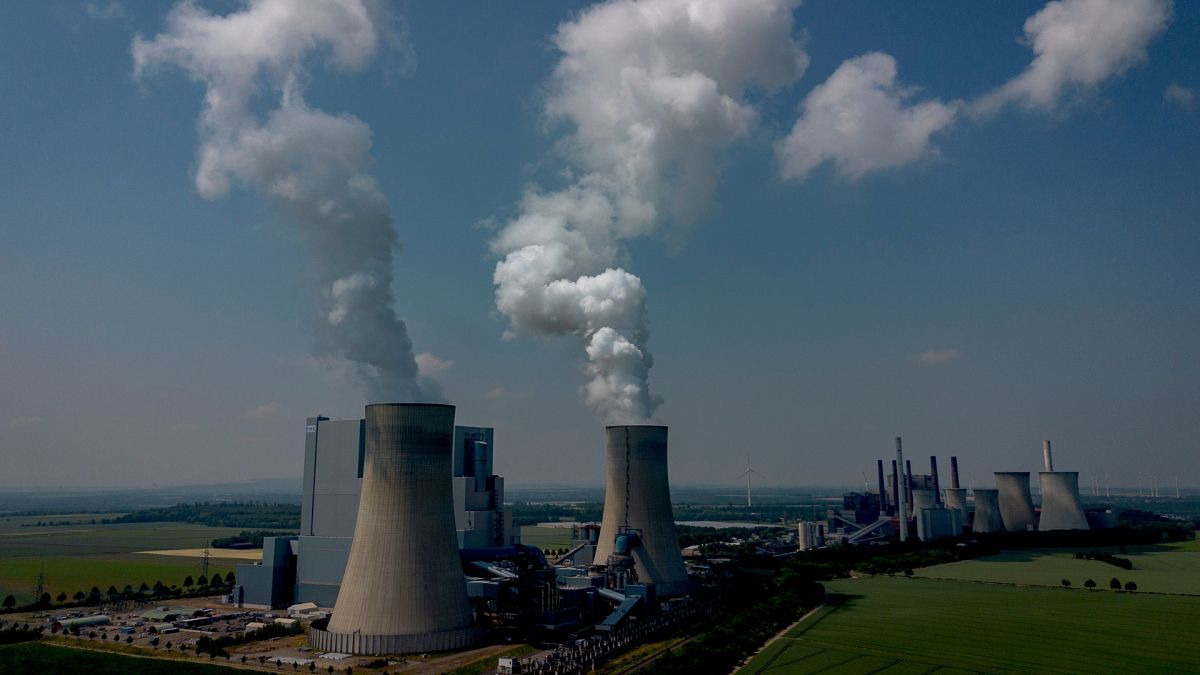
[0,514,247,604]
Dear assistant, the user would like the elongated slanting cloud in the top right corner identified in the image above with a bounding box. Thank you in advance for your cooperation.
[972,0,1172,115]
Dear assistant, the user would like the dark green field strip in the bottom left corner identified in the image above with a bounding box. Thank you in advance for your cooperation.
[0,643,244,675]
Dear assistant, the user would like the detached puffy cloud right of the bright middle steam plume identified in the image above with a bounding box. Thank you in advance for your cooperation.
[775,52,958,180]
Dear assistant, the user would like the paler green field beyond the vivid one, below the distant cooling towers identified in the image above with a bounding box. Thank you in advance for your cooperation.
[916,542,1200,593]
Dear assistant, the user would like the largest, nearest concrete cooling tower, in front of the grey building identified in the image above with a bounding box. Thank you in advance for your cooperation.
[308,404,482,653]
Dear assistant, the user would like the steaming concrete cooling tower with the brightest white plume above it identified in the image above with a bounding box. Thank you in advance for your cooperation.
[595,425,691,596]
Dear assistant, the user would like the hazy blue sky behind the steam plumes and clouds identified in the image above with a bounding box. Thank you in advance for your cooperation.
[0,0,1200,488]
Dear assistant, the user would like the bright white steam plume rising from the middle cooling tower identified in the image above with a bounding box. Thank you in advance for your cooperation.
[491,0,808,423]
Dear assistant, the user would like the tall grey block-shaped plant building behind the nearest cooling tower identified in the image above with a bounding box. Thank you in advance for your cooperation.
[230,417,521,608]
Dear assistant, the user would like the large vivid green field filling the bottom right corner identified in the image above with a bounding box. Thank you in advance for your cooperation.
[739,568,1200,675]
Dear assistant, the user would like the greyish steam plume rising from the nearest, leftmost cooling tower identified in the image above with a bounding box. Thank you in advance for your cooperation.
[132,0,437,401]
